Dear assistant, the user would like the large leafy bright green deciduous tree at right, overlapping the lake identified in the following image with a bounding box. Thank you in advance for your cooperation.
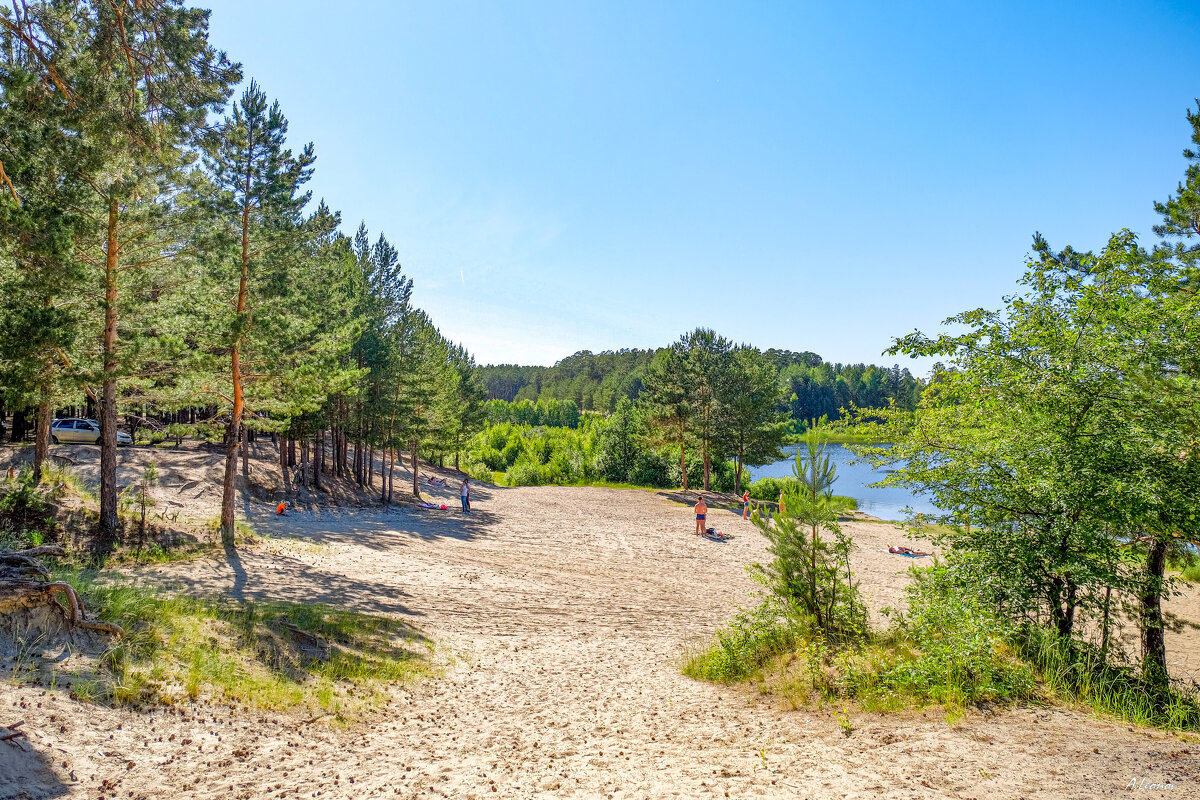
[875,231,1200,686]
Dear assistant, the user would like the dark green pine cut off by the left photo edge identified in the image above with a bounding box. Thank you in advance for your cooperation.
[0,2,90,481]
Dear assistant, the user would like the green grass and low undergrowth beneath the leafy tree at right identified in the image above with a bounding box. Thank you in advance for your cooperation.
[680,570,1200,732]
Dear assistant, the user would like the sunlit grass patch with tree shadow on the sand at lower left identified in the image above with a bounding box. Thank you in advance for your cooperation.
[27,572,433,720]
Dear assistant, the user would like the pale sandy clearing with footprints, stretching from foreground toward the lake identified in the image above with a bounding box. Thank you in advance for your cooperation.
[0,487,1200,798]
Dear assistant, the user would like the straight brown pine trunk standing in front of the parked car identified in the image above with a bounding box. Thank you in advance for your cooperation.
[100,200,120,541]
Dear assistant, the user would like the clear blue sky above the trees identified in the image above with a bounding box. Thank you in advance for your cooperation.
[204,0,1200,371]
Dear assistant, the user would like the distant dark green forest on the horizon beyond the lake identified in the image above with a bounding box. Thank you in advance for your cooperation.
[478,348,923,421]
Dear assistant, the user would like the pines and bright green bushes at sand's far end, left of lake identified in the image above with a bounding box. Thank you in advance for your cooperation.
[468,329,790,491]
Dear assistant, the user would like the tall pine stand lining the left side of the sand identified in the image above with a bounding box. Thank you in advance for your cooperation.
[0,0,485,545]
